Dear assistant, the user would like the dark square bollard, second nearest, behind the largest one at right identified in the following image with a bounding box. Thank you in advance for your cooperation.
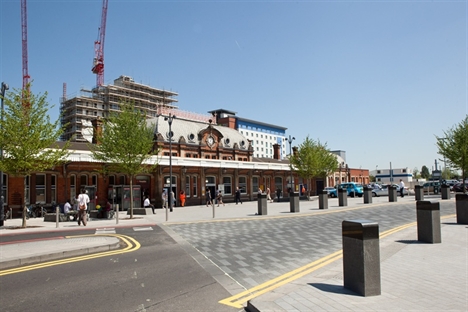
[416,201,441,244]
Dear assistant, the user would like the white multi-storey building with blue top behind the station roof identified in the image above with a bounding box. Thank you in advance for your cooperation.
[208,109,288,159]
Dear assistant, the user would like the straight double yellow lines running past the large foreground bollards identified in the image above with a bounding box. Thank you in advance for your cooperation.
[219,214,455,309]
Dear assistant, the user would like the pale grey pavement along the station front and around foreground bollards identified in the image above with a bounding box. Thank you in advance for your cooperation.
[0,196,468,312]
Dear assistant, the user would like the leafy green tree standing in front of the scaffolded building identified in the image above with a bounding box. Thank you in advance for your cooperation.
[90,101,157,218]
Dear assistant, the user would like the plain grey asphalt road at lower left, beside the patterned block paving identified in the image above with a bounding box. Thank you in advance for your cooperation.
[0,226,239,312]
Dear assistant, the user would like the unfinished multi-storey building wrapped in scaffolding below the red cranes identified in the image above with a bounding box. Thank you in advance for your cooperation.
[60,76,183,142]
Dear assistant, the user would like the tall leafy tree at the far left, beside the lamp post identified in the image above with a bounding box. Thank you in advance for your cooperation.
[0,84,69,227]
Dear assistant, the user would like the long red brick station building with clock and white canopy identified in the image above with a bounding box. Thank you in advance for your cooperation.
[3,112,369,217]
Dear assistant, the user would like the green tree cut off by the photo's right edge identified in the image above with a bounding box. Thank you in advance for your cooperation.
[436,115,468,187]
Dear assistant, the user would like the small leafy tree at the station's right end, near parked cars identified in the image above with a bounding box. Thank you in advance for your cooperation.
[289,136,338,196]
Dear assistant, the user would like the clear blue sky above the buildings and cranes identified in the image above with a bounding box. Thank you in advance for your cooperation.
[0,0,468,170]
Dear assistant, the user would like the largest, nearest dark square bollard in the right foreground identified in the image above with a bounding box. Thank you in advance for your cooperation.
[342,220,381,296]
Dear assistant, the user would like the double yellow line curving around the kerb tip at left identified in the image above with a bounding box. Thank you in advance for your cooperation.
[0,234,141,276]
